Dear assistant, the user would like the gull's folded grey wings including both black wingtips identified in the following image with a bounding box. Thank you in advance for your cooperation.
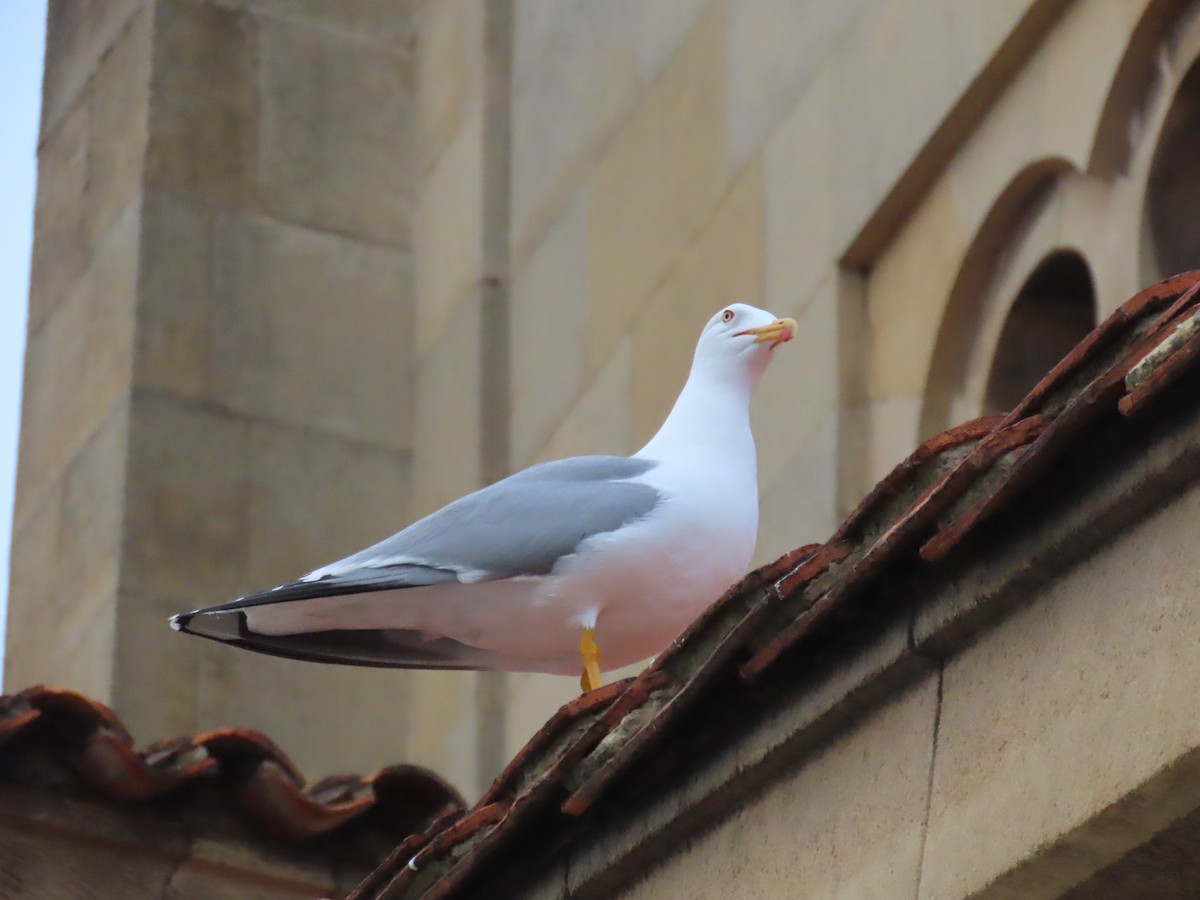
[172,456,661,668]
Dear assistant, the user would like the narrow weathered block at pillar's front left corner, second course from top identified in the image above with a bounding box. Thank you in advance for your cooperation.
[133,190,214,398]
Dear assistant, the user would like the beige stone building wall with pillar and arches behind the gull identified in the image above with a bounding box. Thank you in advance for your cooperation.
[5,0,1200,811]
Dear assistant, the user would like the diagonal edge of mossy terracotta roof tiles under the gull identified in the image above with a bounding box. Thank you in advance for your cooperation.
[352,271,1200,900]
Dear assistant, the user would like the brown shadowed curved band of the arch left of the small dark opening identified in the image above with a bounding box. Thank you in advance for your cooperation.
[920,157,1074,437]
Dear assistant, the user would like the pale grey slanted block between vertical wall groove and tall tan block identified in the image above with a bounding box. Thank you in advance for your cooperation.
[509,192,589,466]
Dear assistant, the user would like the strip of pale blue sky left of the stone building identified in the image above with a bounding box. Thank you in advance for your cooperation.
[0,0,46,672]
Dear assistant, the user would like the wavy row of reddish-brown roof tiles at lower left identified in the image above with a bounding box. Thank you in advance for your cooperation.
[0,686,463,862]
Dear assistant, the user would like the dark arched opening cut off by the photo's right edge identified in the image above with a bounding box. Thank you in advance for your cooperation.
[1142,51,1200,281]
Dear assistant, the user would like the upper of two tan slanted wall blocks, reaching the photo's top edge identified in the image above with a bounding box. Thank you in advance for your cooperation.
[588,4,727,366]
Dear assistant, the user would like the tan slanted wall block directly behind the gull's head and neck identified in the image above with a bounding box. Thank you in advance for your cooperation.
[631,158,763,443]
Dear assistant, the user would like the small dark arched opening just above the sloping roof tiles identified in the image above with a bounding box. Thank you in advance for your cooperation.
[982,250,1096,414]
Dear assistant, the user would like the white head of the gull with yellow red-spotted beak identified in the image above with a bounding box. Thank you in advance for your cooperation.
[692,304,796,386]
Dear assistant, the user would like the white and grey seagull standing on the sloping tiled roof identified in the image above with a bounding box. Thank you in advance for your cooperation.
[170,304,796,691]
